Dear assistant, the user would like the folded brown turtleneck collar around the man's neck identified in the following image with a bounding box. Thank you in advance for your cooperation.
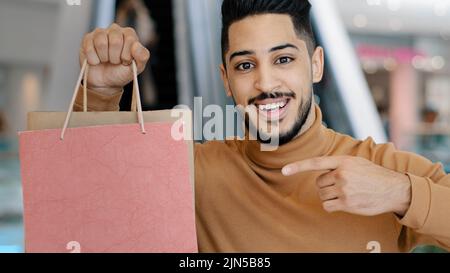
[243,105,333,169]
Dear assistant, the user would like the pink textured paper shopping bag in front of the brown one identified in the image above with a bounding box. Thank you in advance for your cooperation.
[19,122,197,252]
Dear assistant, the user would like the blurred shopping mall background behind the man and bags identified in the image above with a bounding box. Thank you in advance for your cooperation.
[0,0,450,252]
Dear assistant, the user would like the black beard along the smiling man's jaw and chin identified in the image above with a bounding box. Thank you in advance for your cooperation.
[245,92,313,146]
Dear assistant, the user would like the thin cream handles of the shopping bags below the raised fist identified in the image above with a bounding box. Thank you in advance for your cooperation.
[61,60,146,140]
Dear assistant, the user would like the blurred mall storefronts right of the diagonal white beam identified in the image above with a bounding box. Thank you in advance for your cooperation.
[337,0,450,171]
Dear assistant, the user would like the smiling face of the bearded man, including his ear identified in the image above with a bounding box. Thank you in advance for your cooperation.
[221,14,323,145]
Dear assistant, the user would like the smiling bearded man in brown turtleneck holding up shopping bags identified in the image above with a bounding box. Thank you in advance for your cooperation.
[77,0,450,252]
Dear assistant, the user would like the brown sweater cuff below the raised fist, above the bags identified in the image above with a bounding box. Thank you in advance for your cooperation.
[73,87,123,112]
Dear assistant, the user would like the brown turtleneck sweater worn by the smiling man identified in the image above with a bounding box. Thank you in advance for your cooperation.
[76,86,450,252]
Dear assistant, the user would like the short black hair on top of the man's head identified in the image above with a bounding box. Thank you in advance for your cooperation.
[222,0,316,65]
